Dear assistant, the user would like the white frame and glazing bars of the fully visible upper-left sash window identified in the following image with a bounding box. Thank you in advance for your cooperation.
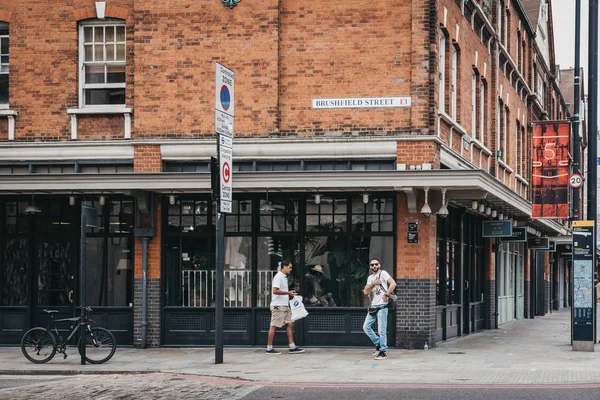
[78,18,127,109]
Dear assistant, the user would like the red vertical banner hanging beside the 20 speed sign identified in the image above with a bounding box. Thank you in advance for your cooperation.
[531,121,570,219]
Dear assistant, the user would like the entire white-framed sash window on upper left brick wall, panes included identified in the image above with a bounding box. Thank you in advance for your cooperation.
[79,20,126,107]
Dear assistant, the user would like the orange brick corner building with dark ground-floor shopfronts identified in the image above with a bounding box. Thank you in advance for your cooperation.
[0,0,568,348]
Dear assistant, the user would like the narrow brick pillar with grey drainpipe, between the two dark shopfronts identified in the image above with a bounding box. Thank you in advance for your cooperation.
[133,145,162,347]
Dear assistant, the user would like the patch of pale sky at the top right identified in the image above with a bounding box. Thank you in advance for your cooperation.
[552,0,589,72]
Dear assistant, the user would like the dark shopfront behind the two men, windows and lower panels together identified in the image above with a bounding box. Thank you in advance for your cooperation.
[162,193,396,346]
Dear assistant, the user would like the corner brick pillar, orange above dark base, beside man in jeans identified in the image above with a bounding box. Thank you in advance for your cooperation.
[396,192,436,349]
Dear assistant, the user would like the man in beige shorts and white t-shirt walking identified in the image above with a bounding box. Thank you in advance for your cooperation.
[266,260,304,355]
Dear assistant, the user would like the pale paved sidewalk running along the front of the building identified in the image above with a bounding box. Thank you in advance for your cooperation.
[0,309,600,385]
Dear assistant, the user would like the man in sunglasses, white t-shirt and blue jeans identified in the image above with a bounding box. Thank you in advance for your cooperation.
[363,258,396,360]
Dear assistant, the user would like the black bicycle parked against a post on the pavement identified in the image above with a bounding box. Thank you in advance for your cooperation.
[21,307,117,364]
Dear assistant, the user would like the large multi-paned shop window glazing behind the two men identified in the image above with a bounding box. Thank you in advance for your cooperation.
[163,193,395,307]
